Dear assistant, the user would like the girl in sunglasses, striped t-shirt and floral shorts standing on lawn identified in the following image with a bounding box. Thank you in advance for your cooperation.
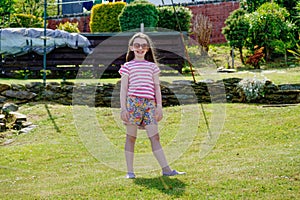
[119,33,184,178]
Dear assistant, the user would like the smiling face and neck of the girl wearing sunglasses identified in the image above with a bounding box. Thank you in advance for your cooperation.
[130,38,149,60]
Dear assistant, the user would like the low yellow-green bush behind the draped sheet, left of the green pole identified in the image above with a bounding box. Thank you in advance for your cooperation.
[10,14,44,28]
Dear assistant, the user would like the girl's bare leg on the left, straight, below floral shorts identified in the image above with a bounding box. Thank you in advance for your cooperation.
[125,125,137,173]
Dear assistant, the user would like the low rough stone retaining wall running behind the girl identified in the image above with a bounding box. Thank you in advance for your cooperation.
[0,78,300,107]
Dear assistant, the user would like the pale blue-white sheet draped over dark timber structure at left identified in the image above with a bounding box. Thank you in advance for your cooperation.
[0,28,91,56]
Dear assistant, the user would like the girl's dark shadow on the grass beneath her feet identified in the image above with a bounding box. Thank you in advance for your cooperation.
[134,176,186,197]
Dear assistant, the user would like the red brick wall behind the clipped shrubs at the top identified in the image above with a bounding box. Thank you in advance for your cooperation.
[48,1,240,44]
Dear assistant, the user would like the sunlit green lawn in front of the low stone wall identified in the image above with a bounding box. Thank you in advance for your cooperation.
[0,103,300,199]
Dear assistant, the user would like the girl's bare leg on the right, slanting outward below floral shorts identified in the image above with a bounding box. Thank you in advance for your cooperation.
[145,125,172,173]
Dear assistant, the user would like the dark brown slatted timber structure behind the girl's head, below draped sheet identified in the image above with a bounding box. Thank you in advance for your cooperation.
[0,32,185,77]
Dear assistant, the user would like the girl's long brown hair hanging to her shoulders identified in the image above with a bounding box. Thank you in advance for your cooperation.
[126,32,157,64]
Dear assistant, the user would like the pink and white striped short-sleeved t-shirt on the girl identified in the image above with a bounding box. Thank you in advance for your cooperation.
[119,60,160,99]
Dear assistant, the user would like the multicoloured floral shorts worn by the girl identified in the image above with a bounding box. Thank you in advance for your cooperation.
[127,96,157,127]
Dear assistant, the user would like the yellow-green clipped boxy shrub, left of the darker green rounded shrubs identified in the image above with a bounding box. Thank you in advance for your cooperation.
[90,2,126,33]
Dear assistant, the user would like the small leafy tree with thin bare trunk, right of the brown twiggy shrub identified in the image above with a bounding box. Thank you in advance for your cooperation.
[222,9,250,64]
